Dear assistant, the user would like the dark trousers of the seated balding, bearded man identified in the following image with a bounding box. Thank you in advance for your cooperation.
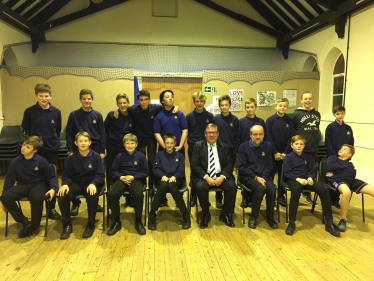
[240,177,275,220]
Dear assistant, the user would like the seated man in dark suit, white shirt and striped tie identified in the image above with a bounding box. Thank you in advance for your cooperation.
[191,123,237,228]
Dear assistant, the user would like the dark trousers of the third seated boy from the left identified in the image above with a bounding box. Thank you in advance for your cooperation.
[108,180,145,220]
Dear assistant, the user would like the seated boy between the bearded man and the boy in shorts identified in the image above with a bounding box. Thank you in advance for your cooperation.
[283,135,340,236]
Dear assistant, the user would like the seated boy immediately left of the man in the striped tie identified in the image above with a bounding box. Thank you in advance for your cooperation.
[148,134,191,230]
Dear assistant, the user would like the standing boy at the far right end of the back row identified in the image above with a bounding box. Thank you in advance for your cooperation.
[325,105,354,208]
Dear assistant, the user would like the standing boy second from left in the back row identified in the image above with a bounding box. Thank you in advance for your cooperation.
[66,89,106,213]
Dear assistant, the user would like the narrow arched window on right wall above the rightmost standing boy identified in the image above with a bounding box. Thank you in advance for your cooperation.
[332,54,345,108]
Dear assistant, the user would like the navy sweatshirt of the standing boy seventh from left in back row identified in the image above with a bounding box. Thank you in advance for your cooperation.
[213,112,240,151]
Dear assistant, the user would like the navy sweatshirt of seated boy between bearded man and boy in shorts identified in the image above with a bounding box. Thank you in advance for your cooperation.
[283,151,317,180]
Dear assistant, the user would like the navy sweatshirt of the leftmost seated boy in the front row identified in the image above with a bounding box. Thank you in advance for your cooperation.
[3,154,57,192]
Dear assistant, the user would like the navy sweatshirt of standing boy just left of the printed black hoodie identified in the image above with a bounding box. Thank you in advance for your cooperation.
[265,113,295,154]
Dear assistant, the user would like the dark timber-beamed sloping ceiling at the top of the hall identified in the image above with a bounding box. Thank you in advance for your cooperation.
[0,0,374,58]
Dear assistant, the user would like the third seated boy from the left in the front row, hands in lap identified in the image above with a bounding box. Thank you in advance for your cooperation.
[107,134,148,235]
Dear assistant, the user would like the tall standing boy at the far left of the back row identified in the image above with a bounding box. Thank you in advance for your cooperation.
[22,84,61,220]
